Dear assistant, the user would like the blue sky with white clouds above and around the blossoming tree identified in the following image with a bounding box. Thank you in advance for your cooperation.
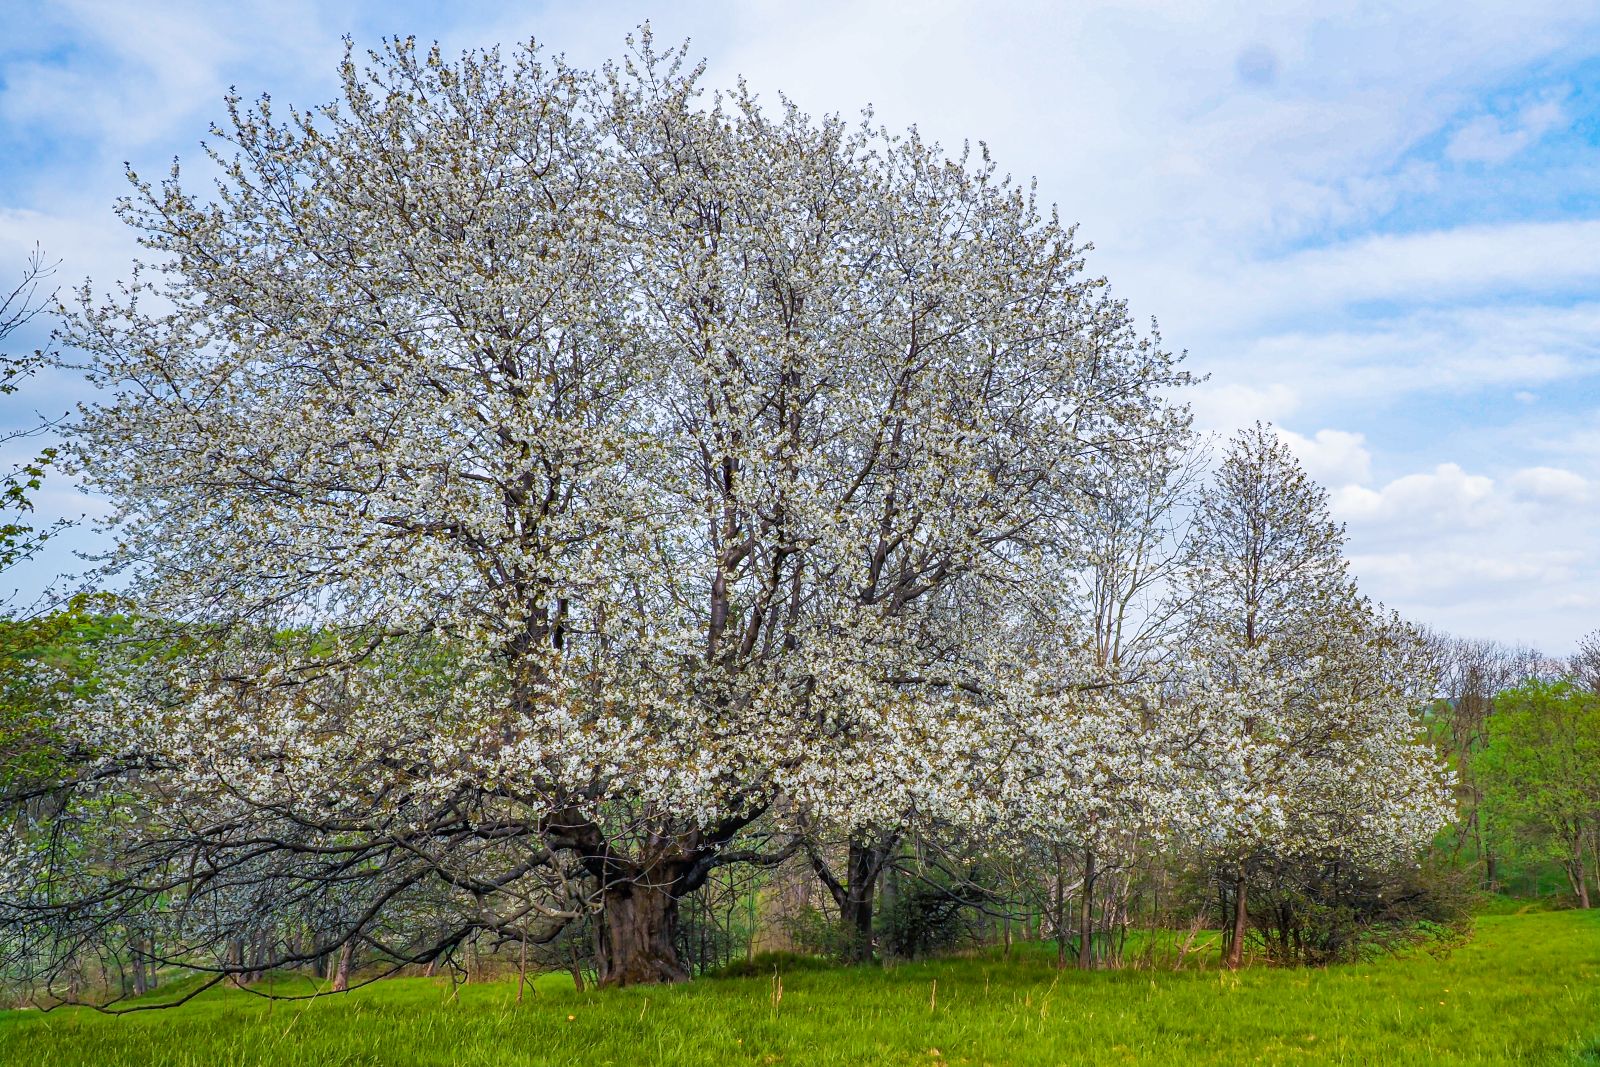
[0,0,1600,653]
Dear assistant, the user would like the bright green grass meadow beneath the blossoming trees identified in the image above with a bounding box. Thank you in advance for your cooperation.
[0,912,1600,1067]
